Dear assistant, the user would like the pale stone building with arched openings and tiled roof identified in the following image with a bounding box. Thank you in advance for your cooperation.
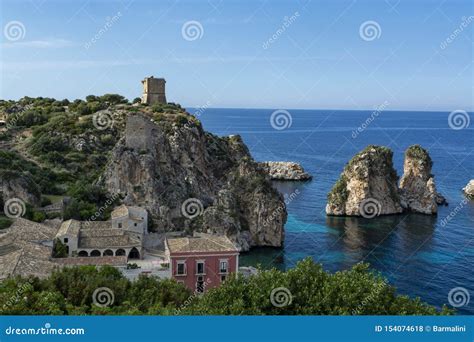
[56,205,148,259]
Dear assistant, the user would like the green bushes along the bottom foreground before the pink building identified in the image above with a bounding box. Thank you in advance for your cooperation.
[0,258,453,315]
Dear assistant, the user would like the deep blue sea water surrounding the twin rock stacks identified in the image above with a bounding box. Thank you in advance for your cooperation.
[189,109,474,314]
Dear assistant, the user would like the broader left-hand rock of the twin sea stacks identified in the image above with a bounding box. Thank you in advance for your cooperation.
[326,145,403,218]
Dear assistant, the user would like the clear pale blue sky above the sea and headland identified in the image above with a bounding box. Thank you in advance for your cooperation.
[0,0,474,111]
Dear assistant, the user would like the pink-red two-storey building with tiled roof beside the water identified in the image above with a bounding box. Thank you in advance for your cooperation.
[165,234,239,292]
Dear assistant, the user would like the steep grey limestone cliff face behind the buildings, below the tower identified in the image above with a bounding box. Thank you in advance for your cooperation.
[101,113,286,250]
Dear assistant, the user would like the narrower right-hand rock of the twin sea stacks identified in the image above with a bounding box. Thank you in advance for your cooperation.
[400,145,439,215]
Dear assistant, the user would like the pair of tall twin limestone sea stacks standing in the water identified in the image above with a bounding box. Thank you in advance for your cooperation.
[326,145,446,218]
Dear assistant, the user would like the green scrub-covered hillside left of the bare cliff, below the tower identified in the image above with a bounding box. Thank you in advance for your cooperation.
[0,94,185,220]
